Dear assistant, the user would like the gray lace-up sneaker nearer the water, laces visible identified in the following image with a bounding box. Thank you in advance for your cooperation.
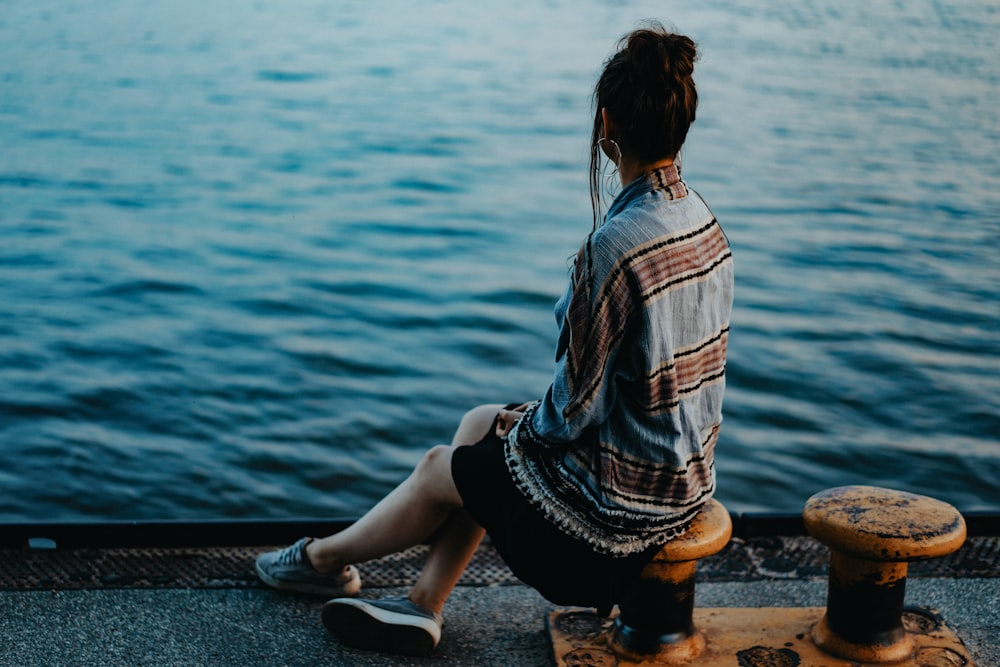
[257,537,361,597]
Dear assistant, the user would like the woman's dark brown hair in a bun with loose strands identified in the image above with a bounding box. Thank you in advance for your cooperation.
[590,22,698,226]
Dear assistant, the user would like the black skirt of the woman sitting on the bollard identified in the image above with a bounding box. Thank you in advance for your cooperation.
[451,412,660,613]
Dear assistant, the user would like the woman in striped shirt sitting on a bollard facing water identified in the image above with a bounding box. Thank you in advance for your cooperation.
[257,24,733,654]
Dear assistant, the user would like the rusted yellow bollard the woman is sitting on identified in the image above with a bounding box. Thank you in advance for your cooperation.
[609,500,733,664]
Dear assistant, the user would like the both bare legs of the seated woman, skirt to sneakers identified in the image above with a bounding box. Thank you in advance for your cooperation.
[306,405,503,611]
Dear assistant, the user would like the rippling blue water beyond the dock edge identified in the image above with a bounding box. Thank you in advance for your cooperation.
[0,0,1000,521]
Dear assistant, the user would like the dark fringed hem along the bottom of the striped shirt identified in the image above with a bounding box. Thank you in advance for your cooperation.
[504,408,715,557]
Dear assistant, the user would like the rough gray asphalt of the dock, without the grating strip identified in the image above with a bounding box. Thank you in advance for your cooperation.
[0,578,1000,667]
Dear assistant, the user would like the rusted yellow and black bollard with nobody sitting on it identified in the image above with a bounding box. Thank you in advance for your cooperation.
[802,486,965,662]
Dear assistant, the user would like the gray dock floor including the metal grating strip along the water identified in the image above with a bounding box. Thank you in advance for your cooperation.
[0,535,1000,667]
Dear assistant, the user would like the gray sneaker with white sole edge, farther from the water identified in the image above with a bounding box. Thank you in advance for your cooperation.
[323,598,442,656]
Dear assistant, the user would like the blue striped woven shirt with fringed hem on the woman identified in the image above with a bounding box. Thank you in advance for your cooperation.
[505,166,733,555]
